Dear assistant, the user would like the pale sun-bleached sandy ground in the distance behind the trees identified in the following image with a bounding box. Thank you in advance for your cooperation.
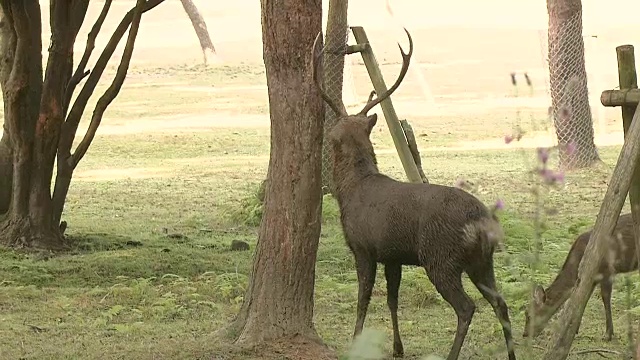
[17,0,640,159]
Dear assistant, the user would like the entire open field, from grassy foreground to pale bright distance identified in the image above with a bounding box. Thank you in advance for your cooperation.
[0,0,640,359]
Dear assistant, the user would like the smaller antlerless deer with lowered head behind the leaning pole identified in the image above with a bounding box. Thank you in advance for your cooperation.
[522,214,638,341]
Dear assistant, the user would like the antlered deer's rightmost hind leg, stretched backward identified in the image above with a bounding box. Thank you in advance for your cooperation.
[467,259,516,360]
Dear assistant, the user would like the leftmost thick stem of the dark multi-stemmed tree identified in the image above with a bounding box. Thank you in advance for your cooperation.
[0,0,59,247]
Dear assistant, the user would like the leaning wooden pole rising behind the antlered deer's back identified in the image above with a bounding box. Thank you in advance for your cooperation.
[351,26,428,183]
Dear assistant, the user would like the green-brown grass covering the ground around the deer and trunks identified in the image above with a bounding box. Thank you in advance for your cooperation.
[0,66,640,359]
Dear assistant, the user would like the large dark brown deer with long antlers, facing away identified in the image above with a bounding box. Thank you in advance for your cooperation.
[313,29,516,360]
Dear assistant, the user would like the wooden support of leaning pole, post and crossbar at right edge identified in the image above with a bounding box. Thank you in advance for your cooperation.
[544,43,640,360]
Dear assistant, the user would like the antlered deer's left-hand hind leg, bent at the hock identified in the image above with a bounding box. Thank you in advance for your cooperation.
[426,267,476,360]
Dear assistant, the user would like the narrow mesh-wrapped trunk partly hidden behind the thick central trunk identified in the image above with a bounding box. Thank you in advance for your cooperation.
[322,6,349,194]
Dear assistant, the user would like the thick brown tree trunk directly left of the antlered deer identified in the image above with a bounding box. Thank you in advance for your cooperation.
[230,0,324,354]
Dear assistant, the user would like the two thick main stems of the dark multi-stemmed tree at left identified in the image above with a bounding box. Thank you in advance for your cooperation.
[0,0,79,249]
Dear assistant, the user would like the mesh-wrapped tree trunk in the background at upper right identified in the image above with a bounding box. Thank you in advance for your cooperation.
[547,0,600,168]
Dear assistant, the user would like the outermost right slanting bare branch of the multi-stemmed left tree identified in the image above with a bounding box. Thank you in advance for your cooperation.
[72,0,145,163]
